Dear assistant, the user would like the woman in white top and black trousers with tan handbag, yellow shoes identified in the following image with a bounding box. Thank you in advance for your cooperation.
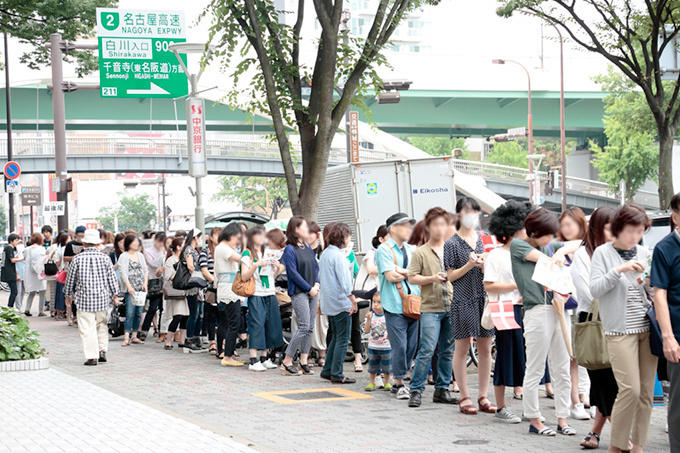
[215,223,247,367]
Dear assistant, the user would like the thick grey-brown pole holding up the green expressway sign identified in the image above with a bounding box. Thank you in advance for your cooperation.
[48,33,69,231]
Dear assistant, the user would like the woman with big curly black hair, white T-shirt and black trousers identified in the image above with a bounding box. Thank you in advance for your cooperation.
[484,200,531,423]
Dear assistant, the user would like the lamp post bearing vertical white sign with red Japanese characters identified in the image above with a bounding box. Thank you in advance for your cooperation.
[170,43,213,242]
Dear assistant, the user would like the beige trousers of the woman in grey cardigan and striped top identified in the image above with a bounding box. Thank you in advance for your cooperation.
[607,332,658,450]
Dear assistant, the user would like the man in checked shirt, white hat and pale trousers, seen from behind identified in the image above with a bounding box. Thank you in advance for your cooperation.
[64,230,119,366]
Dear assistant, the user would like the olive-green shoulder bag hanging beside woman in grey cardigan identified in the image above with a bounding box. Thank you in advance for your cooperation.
[574,299,611,370]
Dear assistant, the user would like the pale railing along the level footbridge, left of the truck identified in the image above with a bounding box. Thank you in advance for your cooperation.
[0,136,397,163]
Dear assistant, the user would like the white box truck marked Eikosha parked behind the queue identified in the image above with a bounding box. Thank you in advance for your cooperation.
[317,157,456,253]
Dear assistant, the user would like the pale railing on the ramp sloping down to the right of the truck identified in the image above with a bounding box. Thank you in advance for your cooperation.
[453,160,659,208]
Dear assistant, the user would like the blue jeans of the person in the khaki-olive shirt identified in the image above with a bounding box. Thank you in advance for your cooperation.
[411,312,456,393]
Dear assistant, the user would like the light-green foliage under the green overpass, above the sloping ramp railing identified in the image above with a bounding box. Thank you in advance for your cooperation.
[486,139,574,170]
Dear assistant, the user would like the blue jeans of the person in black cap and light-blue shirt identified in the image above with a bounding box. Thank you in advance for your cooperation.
[385,311,418,379]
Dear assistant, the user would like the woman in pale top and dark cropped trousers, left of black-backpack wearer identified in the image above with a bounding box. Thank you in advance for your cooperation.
[163,237,189,350]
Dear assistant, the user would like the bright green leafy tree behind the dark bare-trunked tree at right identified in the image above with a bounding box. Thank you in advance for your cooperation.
[591,68,659,201]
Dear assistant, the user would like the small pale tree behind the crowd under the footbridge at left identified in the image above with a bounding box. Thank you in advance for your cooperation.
[97,193,156,232]
